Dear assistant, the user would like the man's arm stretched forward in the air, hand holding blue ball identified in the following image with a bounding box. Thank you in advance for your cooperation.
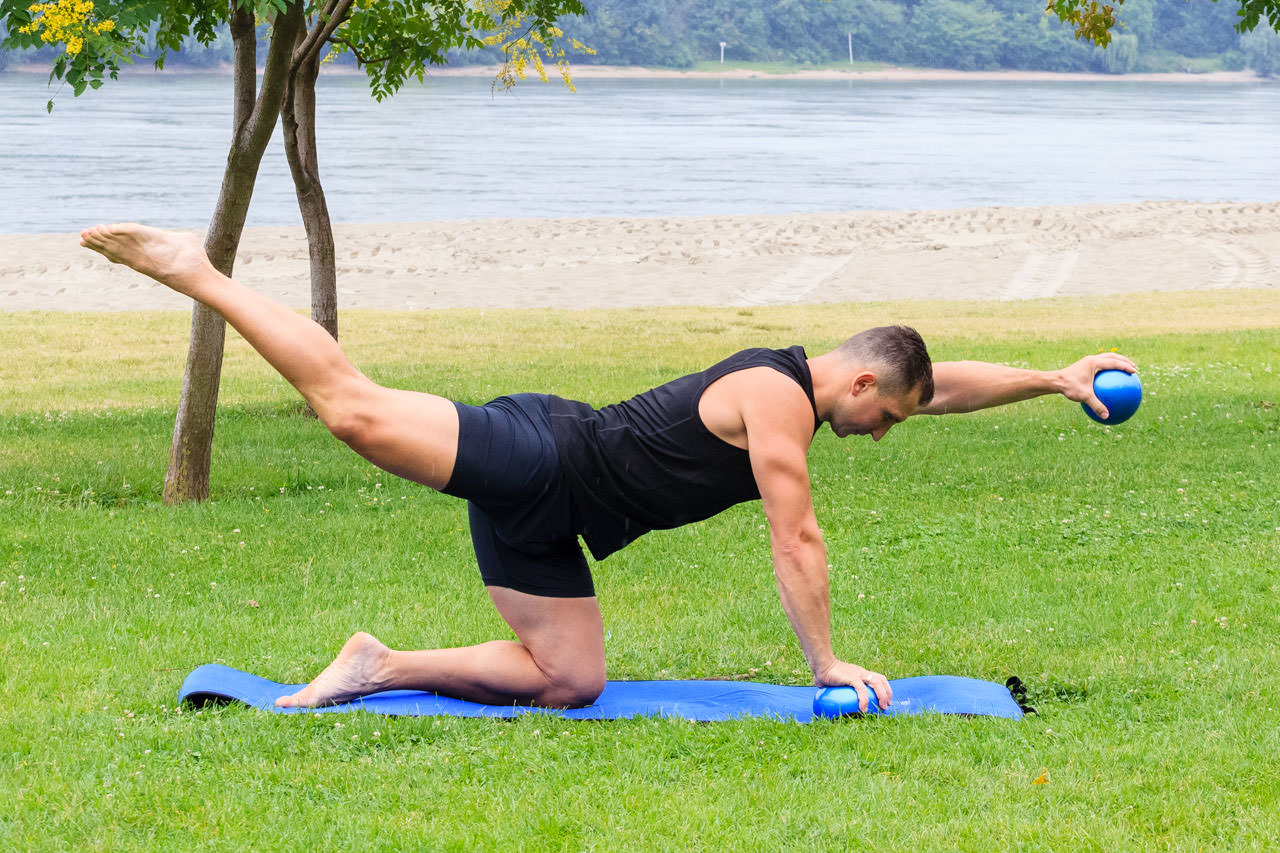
[915,352,1138,418]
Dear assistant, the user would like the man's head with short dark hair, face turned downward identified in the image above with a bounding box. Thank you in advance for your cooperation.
[829,325,933,441]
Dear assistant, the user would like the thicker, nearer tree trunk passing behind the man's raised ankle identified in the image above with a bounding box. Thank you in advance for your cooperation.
[164,0,303,503]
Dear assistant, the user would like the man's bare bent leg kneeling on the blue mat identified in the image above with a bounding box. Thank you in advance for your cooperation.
[275,587,604,708]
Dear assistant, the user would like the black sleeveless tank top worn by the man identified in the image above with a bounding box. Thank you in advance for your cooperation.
[549,346,819,560]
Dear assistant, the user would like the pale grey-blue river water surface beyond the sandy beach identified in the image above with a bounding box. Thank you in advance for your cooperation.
[0,73,1280,233]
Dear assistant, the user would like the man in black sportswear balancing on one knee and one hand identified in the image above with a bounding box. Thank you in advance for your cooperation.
[81,224,1135,711]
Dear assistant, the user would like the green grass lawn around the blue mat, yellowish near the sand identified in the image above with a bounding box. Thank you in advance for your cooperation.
[0,292,1280,850]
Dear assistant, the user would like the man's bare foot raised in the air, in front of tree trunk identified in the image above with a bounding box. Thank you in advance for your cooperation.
[81,223,216,296]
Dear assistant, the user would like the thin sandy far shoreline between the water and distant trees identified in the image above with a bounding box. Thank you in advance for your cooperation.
[0,64,1271,83]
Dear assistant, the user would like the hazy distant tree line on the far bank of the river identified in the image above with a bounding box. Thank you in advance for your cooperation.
[0,0,1280,76]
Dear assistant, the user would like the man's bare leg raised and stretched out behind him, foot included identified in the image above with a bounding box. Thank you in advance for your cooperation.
[81,223,458,488]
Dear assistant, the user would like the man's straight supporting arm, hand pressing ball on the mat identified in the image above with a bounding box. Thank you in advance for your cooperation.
[742,374,892,711]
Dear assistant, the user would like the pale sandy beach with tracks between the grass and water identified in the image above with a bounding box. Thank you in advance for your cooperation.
[0,202,1280,311]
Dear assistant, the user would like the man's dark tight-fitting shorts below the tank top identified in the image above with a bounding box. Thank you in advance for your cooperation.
[442,394,595,598]
